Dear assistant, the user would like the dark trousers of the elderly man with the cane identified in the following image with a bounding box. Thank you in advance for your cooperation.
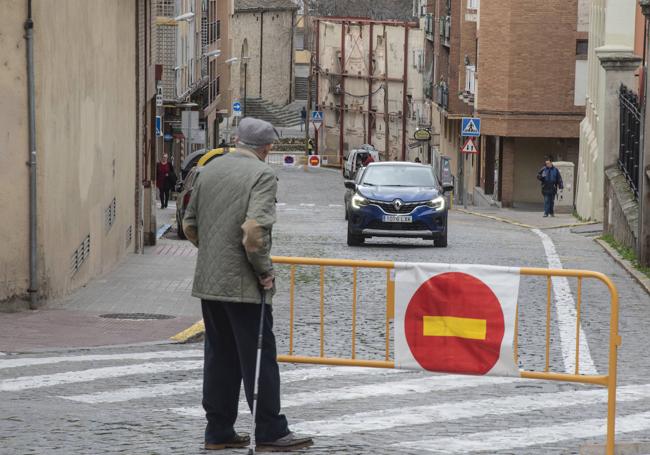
[201,300,289,444]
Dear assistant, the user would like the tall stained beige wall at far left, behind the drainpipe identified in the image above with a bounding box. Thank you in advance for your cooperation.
[0,0,136,306]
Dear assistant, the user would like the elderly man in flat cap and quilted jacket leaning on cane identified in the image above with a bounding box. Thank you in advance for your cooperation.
[183,118,313,452]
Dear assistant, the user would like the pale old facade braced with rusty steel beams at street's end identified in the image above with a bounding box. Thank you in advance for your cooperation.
[315,18,430,163]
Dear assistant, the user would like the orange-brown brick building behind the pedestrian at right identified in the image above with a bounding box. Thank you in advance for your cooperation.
[470,0,589,206]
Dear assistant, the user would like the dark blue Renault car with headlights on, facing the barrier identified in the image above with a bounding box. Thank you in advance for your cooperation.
[345,162,452,247]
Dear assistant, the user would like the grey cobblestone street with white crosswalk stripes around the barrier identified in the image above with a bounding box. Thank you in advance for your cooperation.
[0,168,650,455]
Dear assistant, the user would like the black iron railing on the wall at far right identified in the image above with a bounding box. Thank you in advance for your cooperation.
[618,84,641,200]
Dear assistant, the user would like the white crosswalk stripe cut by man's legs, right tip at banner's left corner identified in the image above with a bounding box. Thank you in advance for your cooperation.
[59,367,409,404]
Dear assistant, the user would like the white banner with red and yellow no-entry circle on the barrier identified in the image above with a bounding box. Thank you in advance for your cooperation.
[395,263,520,376]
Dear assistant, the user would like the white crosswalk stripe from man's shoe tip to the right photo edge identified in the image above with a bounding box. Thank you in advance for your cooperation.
[291,384,650,438]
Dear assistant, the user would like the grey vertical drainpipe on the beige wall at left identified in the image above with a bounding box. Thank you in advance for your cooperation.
[24,0,38,310]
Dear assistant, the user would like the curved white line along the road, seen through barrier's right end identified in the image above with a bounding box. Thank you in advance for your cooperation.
[532,229,598,375]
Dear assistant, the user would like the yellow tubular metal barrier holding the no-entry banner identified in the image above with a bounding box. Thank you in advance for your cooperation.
[273,257,621,455]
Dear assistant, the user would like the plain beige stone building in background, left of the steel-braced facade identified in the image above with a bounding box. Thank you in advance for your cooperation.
[231,11,294,106]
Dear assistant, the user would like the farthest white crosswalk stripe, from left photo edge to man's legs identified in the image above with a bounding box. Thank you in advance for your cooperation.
[0,349,203,370]
